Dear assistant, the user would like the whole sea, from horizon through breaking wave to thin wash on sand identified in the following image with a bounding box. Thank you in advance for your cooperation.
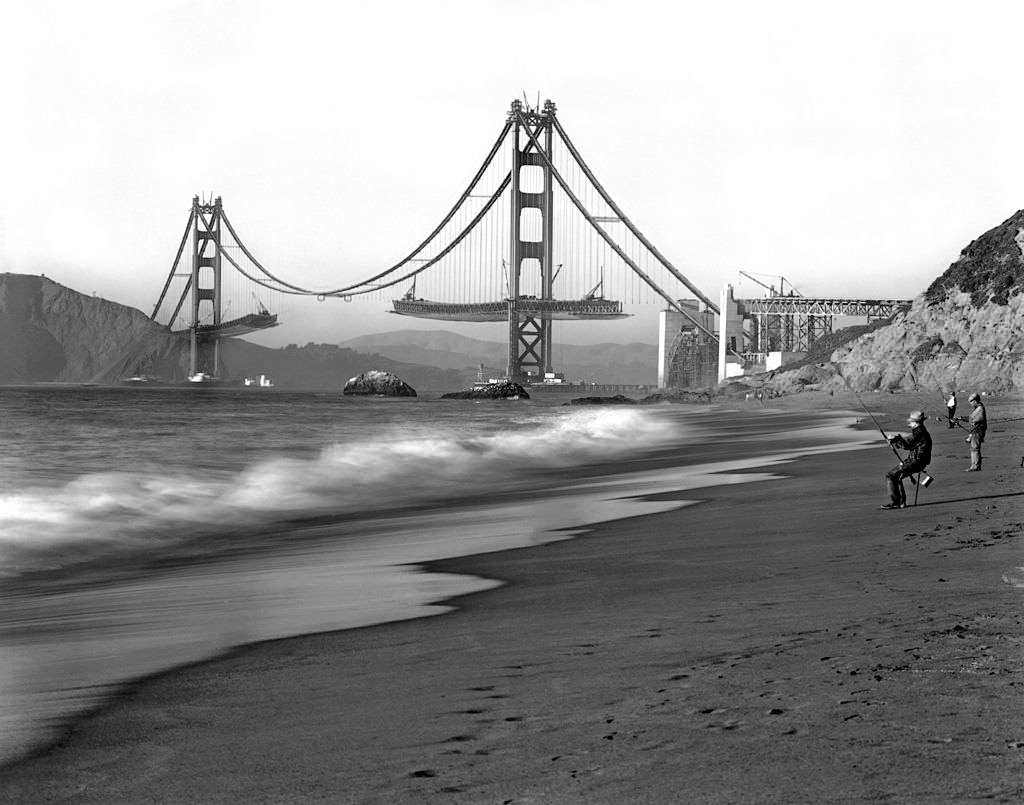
[0,386,864,763]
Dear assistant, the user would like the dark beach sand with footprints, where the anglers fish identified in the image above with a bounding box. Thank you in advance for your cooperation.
[0,394,1024,803]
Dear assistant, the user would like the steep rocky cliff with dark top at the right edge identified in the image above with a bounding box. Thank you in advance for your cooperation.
[770,210,1024,393]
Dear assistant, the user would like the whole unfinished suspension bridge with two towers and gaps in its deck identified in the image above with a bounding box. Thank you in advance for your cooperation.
[151,100,909,387]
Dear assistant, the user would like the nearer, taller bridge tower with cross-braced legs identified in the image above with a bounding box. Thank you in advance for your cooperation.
[508,100,556,380]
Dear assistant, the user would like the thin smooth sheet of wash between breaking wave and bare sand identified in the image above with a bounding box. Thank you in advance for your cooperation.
[0,407,864,761]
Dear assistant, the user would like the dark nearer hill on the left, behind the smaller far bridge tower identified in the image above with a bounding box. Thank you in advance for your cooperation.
[0,273,464,391]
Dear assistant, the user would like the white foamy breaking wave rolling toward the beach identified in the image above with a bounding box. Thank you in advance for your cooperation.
[0,408,680,576]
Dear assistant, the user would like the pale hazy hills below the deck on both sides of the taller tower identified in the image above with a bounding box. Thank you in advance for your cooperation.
[339,330,657,385]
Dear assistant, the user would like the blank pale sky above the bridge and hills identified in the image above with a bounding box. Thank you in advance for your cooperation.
[0,0,1024,346]
